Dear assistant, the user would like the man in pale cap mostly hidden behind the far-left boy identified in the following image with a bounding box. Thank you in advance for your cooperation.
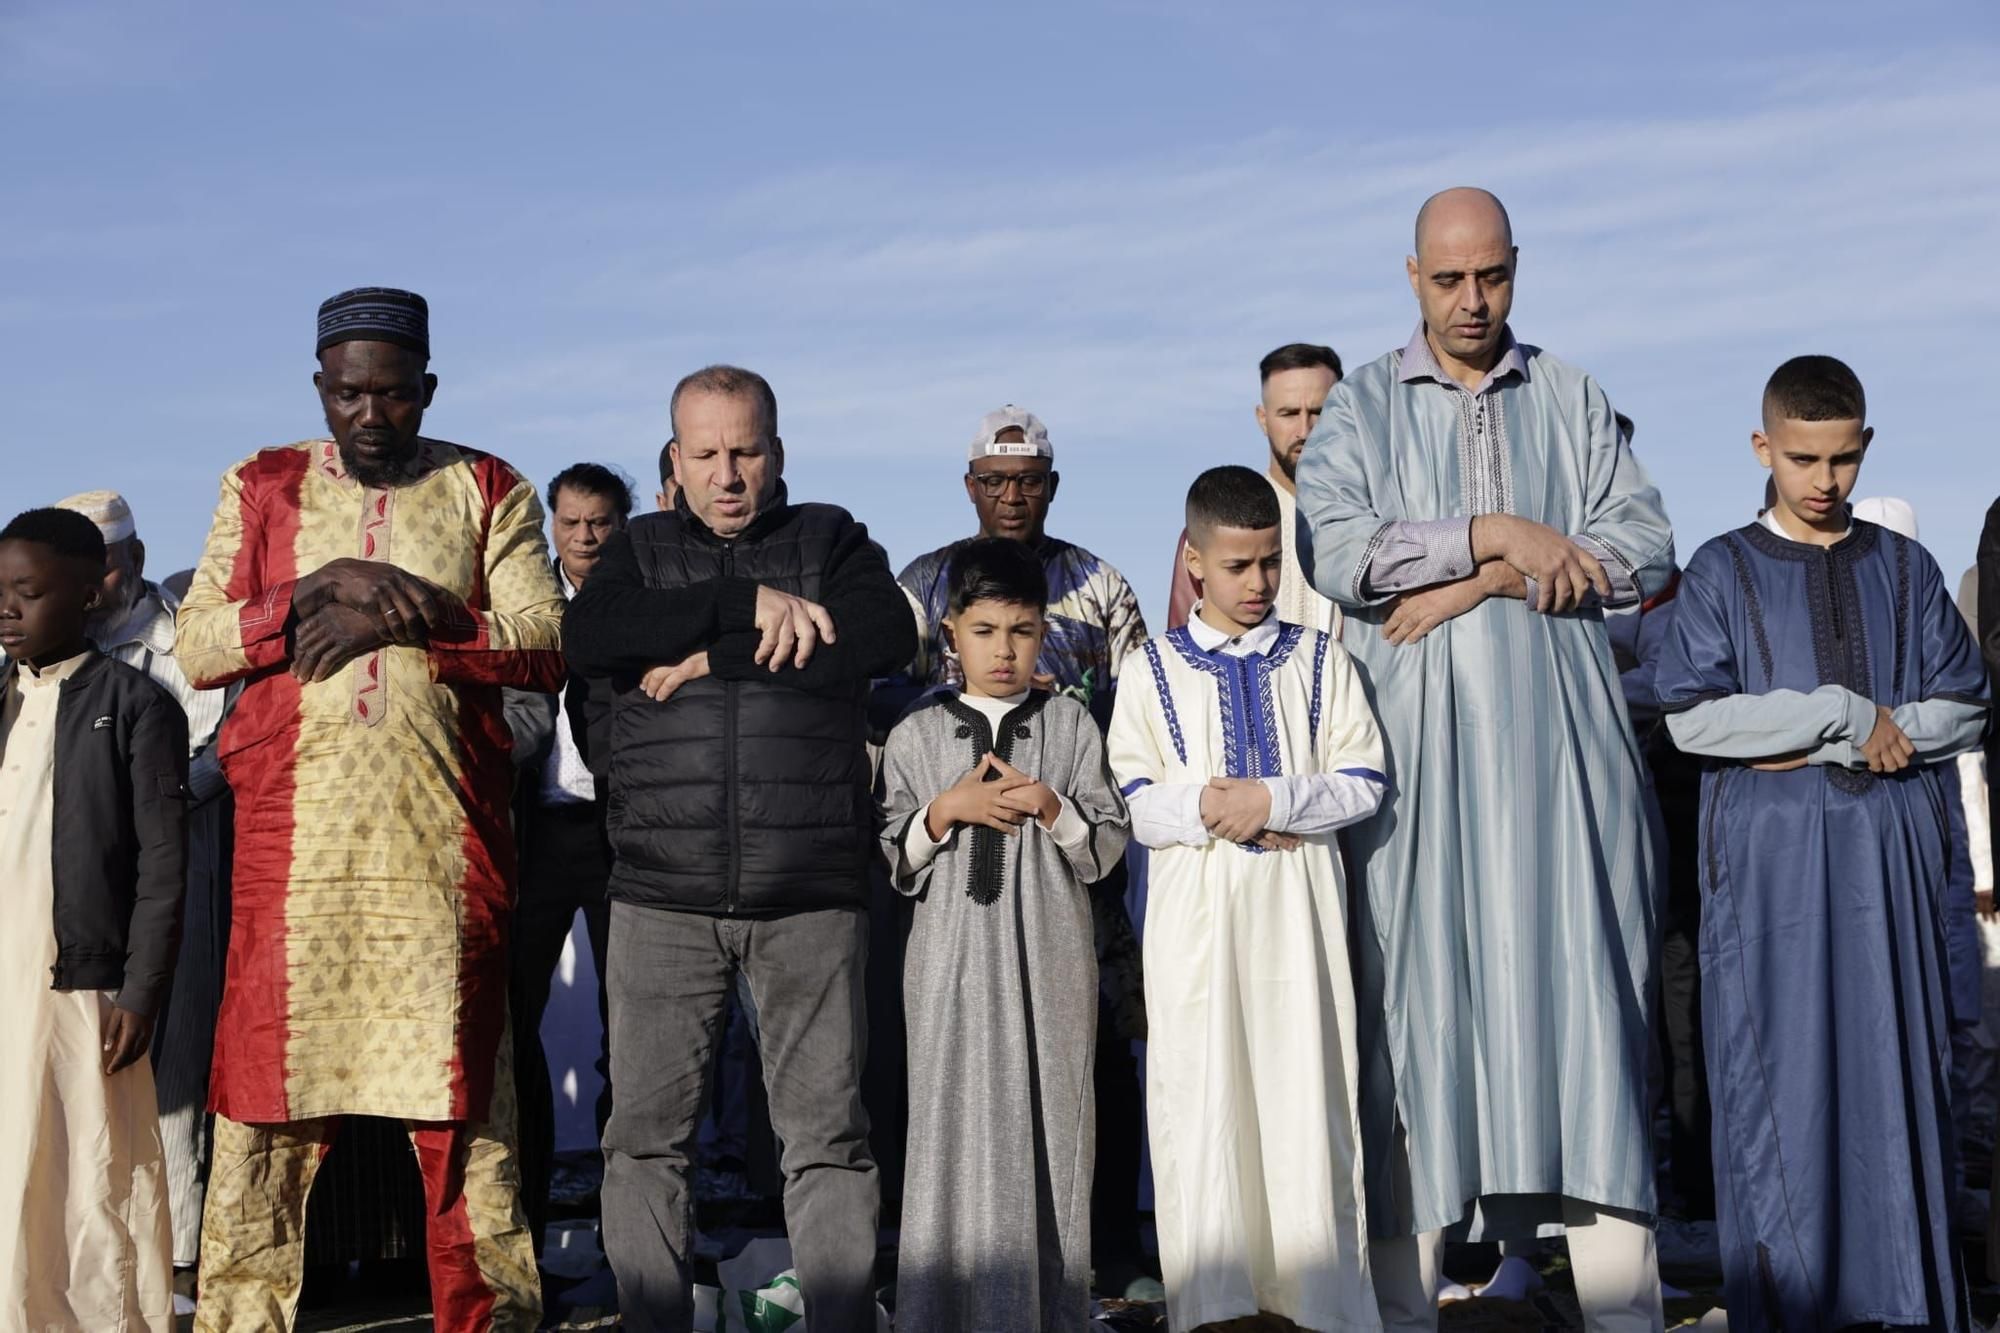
[58,490,230,1297]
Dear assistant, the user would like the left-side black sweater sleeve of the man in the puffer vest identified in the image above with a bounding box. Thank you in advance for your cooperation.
[562,532,756,679]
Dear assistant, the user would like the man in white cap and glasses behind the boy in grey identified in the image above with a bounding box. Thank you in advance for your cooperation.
[890,402,1146,1295]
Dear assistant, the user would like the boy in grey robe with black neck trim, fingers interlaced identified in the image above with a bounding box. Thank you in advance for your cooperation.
[882,538,1128,1333]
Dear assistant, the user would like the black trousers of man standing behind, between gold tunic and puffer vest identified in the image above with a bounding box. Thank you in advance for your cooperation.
[508,801,612,1255]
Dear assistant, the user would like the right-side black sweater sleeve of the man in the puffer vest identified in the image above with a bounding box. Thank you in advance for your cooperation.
[708,522,916,697]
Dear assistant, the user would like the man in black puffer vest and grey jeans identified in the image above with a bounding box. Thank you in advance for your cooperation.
[564,366,916,1333]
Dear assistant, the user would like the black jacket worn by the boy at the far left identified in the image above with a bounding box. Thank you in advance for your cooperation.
[0,648,188,1017]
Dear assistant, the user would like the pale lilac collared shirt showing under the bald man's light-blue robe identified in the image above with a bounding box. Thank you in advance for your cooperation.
[1366,324,1640,606]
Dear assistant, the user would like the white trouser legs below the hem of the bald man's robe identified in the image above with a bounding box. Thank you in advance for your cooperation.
[1368,1199,1666,1333]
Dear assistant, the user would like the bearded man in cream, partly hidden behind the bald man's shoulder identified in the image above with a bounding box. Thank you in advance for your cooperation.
[1166,342,1340,638]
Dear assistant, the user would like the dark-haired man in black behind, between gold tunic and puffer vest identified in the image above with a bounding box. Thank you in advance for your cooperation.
[506,462,632,1253]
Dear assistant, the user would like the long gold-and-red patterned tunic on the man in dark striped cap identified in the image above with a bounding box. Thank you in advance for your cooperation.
[176,440,564,1120]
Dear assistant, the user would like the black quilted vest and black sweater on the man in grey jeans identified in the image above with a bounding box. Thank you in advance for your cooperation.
[562,486,916,917]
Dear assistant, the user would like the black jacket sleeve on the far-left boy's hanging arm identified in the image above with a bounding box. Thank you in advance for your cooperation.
[116,691,188,1017]
